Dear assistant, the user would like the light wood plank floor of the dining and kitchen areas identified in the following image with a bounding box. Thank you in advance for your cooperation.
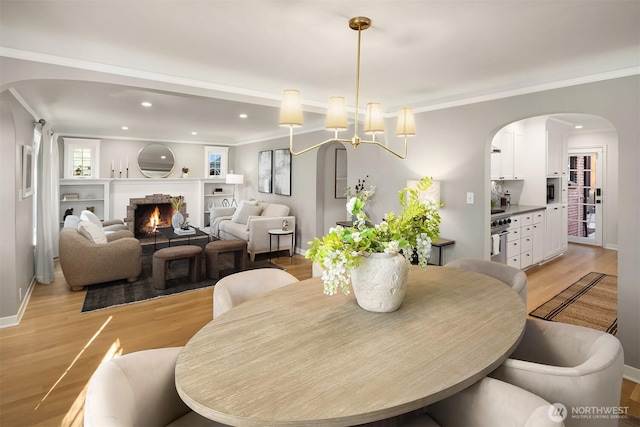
[0,245,640,427]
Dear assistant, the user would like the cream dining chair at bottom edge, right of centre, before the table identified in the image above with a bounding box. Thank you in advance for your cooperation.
[403,377,563,427]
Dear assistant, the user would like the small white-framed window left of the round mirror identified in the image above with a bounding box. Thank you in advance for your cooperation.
[64,138,100,178]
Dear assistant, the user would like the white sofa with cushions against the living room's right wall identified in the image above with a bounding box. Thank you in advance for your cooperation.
[209,200,296,261]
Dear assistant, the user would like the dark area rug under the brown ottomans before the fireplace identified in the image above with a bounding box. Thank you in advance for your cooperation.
[81,254,280,313]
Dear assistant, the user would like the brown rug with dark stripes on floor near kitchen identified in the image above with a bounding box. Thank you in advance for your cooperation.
[529,273,618,335]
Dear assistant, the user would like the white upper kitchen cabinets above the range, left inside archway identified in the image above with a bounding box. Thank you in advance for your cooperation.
[491,130,525,180]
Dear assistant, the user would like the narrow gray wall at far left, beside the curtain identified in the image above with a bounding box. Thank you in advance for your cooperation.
[0,91,34,324]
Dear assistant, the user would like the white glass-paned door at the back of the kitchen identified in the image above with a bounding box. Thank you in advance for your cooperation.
[567,148,605,246]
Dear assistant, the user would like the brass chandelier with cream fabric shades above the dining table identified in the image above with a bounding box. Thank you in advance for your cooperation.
[280,16,416,159]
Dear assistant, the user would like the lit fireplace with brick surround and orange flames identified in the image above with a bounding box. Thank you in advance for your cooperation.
[124,194,188,239]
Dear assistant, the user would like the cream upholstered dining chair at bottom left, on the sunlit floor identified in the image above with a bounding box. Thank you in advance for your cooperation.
[84,347,224,427]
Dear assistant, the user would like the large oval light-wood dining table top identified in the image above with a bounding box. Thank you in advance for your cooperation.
[176,266,526,426]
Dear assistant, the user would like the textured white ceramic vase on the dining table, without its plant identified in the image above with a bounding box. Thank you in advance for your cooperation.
[351,253,409,313]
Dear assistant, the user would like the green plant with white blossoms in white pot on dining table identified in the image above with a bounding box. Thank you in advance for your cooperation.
[305,177,440,311]
